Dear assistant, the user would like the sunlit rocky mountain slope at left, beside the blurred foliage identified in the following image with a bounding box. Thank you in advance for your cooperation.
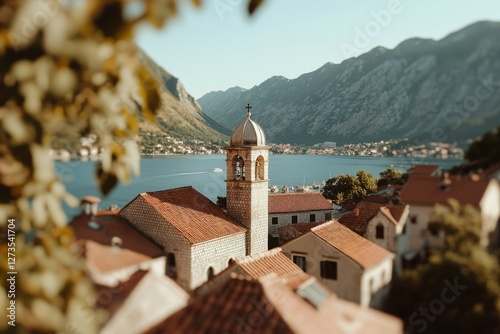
[138,50,230,141]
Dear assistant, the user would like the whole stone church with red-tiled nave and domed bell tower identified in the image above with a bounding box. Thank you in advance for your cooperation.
[116,106,269,291]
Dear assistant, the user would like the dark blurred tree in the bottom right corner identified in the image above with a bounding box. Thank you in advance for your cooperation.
[386,200,500,334]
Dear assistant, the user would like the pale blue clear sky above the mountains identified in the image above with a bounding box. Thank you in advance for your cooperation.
[137,0,500,98]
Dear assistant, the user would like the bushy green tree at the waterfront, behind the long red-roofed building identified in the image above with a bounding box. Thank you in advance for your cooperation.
[323,170,377,201]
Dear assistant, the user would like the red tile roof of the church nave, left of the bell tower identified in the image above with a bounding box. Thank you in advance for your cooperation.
[127,187,246,244]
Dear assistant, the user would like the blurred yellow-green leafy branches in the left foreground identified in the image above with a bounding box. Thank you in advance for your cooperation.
[0,0,261,333]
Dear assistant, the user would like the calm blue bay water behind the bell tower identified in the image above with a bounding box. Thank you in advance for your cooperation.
[56,155,460,216]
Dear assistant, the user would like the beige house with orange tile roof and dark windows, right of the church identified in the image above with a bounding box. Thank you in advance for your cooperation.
[281,220,394,306]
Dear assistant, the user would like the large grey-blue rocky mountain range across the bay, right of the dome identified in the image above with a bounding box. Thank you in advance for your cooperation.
[198,22,500,144]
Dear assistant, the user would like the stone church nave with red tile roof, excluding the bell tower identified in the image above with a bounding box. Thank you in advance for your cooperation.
[120,187,247,290]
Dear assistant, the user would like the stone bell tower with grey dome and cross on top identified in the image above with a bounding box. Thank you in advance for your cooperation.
[226,104,269,254]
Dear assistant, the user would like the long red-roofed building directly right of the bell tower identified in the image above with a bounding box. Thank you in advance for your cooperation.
[268,193,333,238]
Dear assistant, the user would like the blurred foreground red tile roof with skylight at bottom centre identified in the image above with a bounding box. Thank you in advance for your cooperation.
[146,274,403,334]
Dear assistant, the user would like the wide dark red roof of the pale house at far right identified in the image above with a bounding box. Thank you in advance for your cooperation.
[401,175,493,206]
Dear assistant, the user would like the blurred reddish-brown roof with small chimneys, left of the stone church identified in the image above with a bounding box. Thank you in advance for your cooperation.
[69,213,165,267]
